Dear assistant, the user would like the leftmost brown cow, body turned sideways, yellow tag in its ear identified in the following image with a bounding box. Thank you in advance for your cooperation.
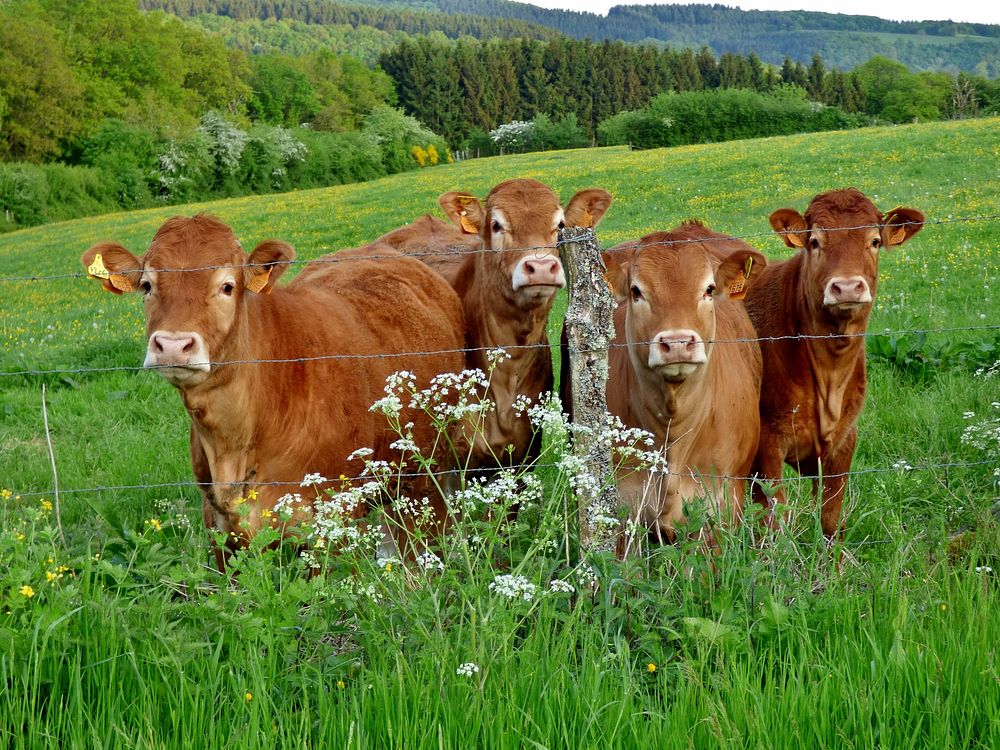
[82,215,464,569]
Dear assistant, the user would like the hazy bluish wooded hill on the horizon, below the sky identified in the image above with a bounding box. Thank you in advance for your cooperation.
[355,0,1000,78]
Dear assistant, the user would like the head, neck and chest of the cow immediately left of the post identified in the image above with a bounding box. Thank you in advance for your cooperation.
[439,179,611,468]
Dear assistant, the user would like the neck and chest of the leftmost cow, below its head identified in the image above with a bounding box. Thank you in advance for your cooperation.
[181,294,271,512]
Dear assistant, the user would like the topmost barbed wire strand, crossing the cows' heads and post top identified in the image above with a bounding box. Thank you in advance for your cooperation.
[0,214,1000,283]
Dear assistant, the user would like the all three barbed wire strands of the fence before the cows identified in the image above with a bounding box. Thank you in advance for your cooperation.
[0,214,1000,512]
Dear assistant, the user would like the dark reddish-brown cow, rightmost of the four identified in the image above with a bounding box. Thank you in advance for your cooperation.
[746,188,924,537]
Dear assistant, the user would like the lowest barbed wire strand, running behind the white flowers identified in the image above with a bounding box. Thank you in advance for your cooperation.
[7,459,996,499]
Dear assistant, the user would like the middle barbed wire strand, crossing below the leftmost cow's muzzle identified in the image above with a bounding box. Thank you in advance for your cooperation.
[0,324,1000,377]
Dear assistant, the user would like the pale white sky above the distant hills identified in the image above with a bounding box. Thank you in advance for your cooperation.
[519,0,1000,24]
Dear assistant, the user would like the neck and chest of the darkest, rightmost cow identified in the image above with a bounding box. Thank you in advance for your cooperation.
[795,264,870,456]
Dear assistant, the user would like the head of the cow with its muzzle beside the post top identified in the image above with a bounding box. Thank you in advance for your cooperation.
[438,179,611,309]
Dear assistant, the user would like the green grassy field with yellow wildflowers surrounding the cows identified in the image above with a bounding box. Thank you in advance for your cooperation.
[0,119,1000,748]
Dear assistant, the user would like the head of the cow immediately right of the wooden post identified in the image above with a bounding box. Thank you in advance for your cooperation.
[603,228,766,384]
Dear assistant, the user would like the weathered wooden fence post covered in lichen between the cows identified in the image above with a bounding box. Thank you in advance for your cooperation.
[559,227,621,554]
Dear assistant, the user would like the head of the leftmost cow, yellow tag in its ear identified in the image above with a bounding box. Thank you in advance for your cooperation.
[81,215,295,388]
